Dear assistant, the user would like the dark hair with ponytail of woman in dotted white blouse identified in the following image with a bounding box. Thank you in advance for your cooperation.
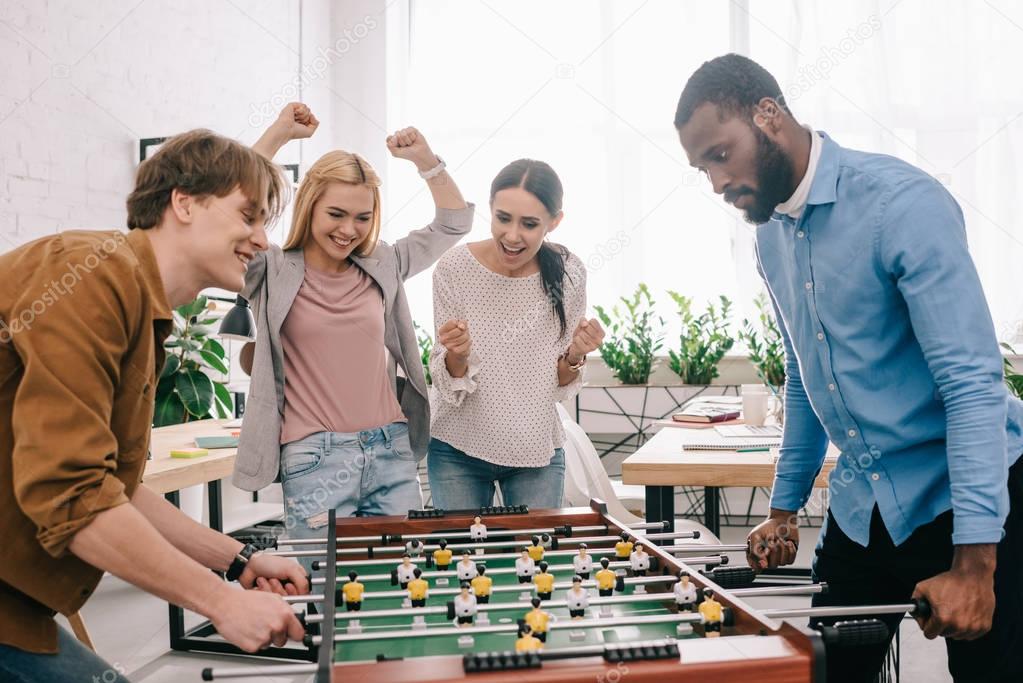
[490,158,569,336]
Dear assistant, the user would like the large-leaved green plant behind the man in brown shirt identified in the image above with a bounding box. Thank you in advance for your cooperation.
[152,297,233,426]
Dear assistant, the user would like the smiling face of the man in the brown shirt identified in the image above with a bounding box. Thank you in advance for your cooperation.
[185,188,267,291]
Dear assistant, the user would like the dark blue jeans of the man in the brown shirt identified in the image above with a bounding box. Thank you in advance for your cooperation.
[0,626,128,683]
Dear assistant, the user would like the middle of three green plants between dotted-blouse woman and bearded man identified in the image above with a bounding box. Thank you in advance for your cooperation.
[668,291,736,384]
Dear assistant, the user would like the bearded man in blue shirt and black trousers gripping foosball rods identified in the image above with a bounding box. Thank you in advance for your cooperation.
[675,54,1023,682]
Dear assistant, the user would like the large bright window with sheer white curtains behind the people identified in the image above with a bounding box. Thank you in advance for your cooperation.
[385,0,1023,338]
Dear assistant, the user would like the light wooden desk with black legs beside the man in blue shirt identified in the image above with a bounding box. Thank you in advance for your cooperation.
[622,428,838,535]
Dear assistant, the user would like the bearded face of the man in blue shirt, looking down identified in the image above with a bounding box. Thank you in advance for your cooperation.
[678,102,795,224]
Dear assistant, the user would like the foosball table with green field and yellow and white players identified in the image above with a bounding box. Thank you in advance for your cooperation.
[203,501,927,683]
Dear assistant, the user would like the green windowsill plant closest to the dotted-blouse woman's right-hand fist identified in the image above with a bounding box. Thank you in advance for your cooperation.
[593,283,664,384]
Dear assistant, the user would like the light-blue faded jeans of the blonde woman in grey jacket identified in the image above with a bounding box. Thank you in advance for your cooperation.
[280,422,422,572]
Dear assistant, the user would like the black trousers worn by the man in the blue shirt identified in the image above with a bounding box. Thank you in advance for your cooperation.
[811,459,1023,683]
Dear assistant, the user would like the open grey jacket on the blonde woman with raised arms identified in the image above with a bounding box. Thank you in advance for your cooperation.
[232,204,474,491]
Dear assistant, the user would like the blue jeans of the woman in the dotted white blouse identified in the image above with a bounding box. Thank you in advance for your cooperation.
[427,439,565,510]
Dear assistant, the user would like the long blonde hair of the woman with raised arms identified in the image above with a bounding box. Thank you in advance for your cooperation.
[283,149,381,257]
